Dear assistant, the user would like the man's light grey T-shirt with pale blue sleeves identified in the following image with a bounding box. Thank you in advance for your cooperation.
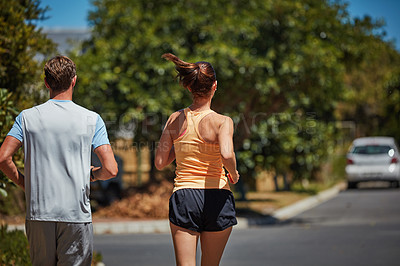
[21,100,109,223]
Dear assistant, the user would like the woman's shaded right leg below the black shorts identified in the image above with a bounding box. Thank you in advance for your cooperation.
[200,226,232,266]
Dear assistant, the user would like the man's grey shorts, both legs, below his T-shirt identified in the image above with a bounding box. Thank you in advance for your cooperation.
[25,221,93,266]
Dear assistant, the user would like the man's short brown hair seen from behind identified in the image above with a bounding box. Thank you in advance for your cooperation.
[44,55,76,91]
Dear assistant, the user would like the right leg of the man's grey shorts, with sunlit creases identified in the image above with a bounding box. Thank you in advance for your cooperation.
[57,223,93,266]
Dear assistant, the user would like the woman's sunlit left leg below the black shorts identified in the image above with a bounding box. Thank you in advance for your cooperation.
[169,223,200,266]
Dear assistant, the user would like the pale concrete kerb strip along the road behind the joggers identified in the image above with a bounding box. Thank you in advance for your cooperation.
[8,183,345,235]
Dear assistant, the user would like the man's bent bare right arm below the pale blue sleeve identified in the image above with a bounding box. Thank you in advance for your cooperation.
[91,144,118,181]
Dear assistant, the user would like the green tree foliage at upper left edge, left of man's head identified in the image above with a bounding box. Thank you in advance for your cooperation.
[0,0,55,105]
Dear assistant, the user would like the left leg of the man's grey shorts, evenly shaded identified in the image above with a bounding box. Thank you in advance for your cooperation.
[25,221,57,266]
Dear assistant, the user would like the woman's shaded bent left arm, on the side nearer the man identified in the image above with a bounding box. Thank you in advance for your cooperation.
[154,114,175,170]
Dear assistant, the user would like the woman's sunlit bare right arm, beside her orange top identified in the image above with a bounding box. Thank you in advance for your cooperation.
[218,117,239,184]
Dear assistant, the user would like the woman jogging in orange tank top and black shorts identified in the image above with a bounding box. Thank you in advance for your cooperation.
[155,54,239,266]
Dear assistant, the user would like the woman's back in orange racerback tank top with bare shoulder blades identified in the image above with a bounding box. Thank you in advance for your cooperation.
[170,108,229,190]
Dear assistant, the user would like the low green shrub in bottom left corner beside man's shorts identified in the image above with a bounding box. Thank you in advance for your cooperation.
[0,225,31,266]
